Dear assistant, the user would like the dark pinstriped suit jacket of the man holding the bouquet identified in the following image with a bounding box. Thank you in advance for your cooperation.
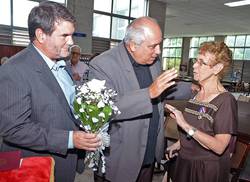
[0,45,84,182]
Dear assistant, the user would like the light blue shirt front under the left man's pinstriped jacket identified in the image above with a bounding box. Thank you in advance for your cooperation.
[51,60,75,111]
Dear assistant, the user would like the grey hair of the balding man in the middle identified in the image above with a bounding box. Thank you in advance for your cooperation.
[124,17,157,45]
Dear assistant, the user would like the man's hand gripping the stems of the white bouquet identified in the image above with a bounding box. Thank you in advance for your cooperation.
[73,131,101,151]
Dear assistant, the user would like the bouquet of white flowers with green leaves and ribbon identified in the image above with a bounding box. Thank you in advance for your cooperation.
[74,79,120,173]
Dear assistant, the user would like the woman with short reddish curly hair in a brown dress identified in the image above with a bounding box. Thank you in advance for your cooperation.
[166,41,237,182]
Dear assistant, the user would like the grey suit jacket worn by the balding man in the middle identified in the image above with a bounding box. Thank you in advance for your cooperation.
[90,43,164,182]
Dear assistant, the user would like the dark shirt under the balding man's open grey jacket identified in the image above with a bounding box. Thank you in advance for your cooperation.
[127,47,160,165]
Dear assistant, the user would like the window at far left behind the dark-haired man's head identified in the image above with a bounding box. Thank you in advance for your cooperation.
[0,0,67,46]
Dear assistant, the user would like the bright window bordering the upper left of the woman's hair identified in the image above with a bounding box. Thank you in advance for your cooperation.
[189,37,214,58]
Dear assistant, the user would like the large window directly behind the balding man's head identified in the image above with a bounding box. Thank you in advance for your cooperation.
[92,0,148,42]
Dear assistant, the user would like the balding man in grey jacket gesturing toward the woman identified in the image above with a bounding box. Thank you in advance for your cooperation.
[90,17,177,182]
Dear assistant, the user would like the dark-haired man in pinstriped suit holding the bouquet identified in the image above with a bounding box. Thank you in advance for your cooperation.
[0,2,100,182]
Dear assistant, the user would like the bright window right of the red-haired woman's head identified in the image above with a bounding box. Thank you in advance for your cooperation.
[225,35,250,61]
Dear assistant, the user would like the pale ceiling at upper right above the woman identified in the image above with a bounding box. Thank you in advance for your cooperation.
[158,0,250,37]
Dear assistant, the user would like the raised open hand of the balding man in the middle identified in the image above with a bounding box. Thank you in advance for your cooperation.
[149,68,177,99]
